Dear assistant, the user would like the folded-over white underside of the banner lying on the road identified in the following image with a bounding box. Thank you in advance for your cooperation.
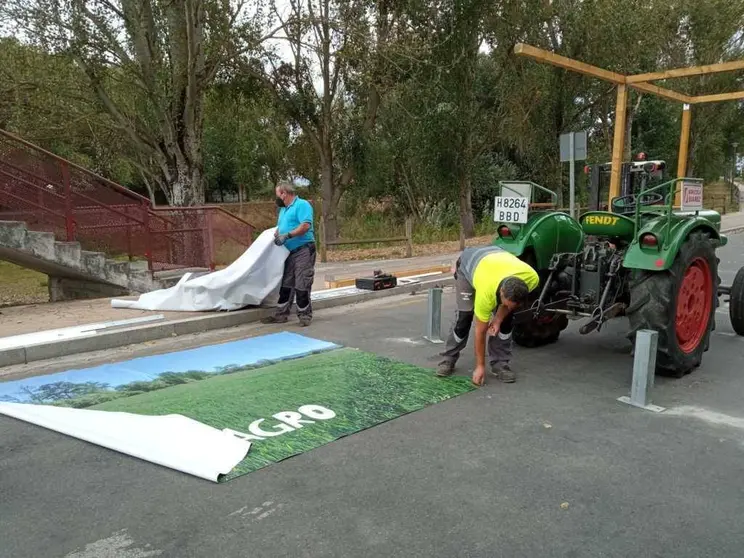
[0,403,251,482]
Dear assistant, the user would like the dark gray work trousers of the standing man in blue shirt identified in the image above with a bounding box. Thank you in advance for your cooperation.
[275,243,316,318]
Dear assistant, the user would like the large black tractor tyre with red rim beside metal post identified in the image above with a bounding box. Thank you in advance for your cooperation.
[626,233,718,378]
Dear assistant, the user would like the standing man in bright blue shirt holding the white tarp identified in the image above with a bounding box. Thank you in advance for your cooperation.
[262,182,315,327]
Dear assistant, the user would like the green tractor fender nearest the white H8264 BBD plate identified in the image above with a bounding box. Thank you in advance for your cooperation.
[492,211,584,270]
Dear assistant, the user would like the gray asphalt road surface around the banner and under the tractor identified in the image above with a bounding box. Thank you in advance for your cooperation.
[0,235,744,558]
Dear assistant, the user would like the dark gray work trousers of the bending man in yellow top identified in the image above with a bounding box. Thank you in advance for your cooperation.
[439,261,512,366]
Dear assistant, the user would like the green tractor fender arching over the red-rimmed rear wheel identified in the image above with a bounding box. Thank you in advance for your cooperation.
[623,216,727,271]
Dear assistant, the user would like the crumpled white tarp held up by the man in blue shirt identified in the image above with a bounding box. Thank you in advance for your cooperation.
[111,228,289,312]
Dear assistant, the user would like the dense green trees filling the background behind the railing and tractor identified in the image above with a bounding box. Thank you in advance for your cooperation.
[0,0,744,230]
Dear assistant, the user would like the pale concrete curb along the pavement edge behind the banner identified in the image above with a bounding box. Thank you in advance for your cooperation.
[0,275,455,368]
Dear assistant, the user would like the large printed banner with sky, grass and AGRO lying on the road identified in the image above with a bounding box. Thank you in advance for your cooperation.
[0,334,474,486]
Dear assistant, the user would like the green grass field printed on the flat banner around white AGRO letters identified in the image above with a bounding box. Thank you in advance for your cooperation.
[91,349,475,480]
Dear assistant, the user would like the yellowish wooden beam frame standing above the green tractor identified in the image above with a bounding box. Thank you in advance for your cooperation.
[514,43,744,206]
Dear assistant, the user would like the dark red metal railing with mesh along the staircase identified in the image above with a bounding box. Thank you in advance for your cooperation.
[0,130,254,271]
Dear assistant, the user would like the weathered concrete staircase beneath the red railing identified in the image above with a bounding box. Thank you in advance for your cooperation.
[0,221,187,302]
